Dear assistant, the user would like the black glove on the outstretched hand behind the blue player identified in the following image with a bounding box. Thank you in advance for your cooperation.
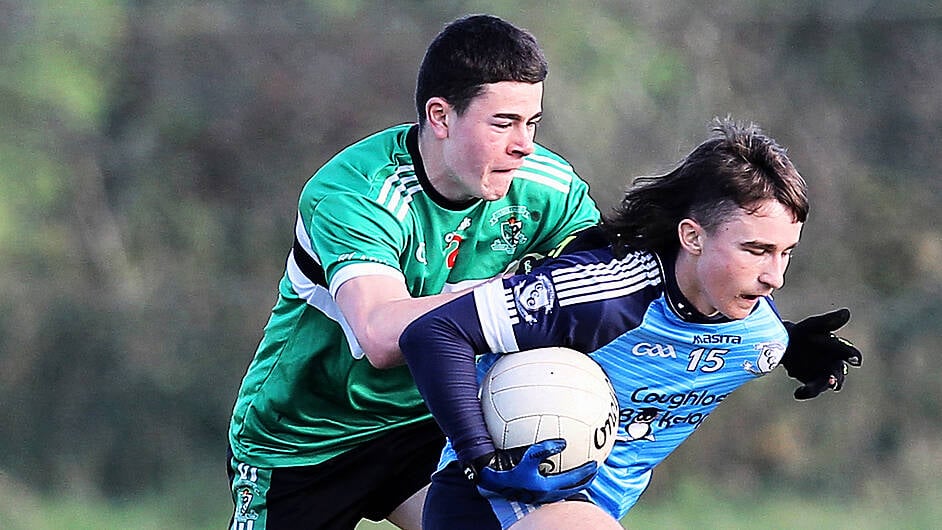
[782,308,863,399]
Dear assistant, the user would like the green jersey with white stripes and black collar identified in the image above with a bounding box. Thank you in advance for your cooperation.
[229,124,599,467]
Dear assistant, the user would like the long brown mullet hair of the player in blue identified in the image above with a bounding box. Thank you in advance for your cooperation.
[602,118,809,255]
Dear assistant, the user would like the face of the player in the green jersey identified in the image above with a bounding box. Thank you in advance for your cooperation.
[435,81,543,201]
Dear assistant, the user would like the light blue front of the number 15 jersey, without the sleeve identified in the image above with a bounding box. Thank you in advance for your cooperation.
[588,296,787,519]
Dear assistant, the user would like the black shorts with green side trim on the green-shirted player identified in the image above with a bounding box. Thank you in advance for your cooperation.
[229,420,445,530]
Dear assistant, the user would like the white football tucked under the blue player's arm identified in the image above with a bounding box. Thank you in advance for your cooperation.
[481,347,618,474]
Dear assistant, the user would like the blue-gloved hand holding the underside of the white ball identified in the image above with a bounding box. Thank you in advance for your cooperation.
[465,439,598,504]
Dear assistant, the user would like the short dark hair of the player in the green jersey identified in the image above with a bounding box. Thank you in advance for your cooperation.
[415,15,547,126]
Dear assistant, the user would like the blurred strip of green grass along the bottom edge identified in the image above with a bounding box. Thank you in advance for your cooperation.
[0,474,942,530]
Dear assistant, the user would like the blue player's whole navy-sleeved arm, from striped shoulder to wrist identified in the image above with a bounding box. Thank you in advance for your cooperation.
[399,245,632,436]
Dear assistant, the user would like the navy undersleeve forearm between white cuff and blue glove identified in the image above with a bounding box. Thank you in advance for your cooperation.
[399,295,494,461]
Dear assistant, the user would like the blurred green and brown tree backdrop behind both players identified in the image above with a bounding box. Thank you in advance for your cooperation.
[0,0,942,524]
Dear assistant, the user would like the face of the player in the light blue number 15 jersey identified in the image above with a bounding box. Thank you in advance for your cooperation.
[684,201,802,319]
